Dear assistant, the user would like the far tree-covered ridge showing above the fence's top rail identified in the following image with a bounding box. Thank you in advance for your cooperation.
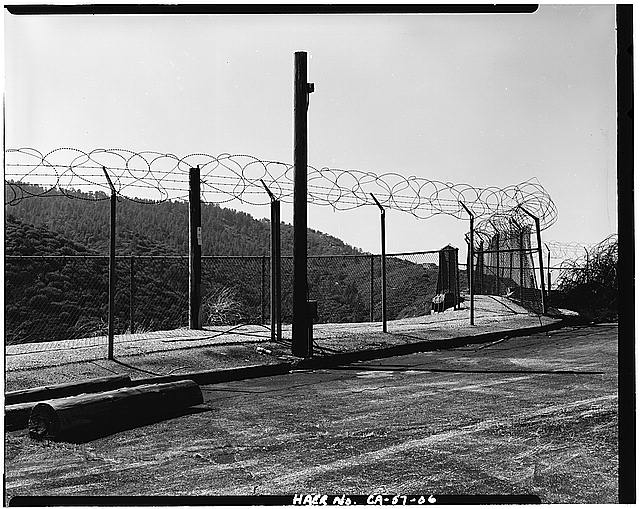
[5,182,360,256]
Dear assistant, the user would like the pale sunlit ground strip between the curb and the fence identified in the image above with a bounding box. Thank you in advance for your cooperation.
[5,295,556,390]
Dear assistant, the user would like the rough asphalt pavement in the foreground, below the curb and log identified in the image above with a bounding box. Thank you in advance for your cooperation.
[5,325,617,503]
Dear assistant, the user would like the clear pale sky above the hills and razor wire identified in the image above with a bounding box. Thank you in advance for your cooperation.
[4,5,617,253]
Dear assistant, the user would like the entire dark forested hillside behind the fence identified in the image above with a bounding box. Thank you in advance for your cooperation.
[5,185,437,344]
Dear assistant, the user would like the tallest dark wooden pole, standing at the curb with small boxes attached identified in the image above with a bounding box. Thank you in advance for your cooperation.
[291,51,313,357]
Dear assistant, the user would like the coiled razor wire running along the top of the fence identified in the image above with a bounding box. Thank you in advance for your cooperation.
[5,147,557,235]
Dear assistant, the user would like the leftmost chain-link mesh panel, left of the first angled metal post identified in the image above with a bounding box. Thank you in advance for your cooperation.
[5,256,109,344]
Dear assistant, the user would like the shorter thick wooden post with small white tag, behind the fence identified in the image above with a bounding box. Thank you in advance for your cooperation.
[189,166,202,329]
